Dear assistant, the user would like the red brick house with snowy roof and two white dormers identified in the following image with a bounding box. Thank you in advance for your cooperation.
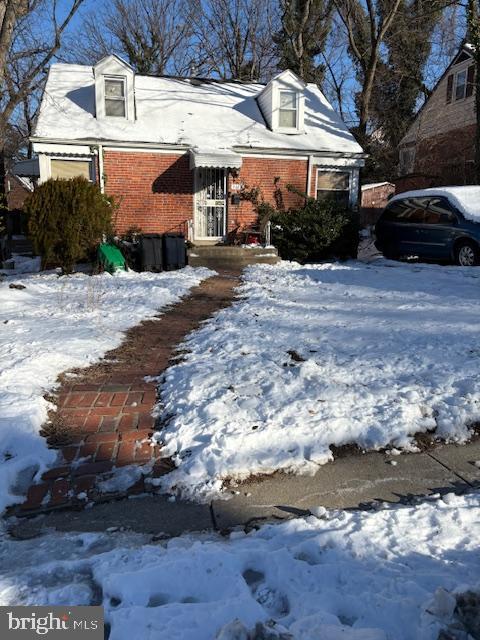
[27,55,365,241]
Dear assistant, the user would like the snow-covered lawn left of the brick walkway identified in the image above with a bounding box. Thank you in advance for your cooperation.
[0,268,212,512]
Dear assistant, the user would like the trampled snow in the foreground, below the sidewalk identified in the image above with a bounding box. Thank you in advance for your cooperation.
[0,494,480,640]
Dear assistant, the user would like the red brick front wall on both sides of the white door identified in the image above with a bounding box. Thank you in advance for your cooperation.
[104,151,313,233]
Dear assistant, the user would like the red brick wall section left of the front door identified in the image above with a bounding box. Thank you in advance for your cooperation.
[104,151,193,233]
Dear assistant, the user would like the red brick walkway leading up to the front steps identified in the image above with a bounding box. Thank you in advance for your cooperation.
[15,273,238,515]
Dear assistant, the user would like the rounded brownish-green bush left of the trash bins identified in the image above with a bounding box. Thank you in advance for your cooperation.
[24,177,115,273]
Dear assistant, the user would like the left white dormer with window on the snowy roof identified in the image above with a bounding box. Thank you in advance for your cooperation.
[93,55,135,121]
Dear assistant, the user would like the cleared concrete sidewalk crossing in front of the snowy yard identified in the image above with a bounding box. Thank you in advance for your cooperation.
[12,439,480,538]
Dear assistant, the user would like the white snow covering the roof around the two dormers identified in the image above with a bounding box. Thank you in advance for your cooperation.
[35,64,363,154]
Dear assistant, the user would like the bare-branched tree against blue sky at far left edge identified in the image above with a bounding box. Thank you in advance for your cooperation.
[0,0,84,193]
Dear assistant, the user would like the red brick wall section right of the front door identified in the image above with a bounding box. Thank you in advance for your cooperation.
[228,158,308,231]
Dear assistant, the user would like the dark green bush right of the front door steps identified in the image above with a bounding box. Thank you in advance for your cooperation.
[270,192,359,263]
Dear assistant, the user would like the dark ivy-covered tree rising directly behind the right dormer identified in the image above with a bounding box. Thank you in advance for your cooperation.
[274,0,334,84]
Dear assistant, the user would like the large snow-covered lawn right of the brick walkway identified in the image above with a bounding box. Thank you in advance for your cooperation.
[158,260,480,500]
